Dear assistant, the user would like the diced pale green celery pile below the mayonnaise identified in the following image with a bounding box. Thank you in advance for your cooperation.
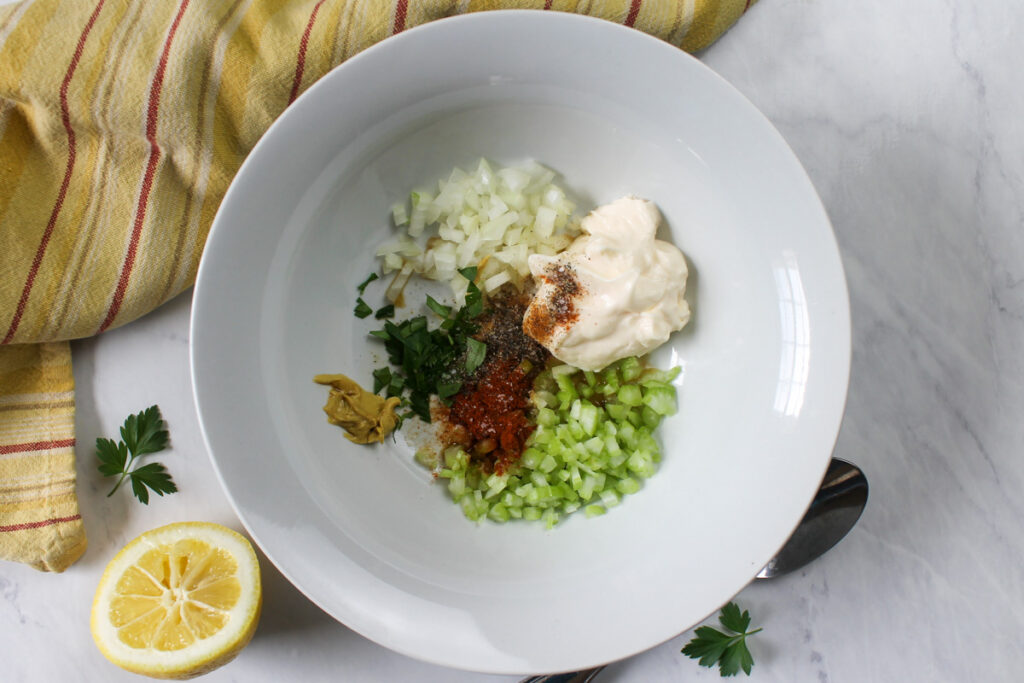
[425,358,679,527]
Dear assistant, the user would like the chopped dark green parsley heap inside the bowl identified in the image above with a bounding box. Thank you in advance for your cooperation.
[370,267,487,422]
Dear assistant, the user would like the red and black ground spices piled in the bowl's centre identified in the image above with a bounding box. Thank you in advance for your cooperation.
[437,293,548,474]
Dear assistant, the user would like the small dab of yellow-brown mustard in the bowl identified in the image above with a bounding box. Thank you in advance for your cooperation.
[313,375,400,443]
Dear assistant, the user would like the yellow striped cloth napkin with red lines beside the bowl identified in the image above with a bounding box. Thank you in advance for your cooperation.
[0,0,752,571]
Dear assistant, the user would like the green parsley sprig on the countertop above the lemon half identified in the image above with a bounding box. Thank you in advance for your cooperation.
[96,405,178,505]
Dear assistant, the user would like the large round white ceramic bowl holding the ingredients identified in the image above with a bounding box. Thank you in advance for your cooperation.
[191,12,850,673]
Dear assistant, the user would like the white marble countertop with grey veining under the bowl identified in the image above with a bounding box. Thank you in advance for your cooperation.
[0,0,1024,683]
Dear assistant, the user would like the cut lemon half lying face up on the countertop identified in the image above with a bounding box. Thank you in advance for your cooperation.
[90,522,262,679]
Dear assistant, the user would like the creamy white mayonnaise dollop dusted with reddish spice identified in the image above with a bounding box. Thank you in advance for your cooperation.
[522,197,690,370]
